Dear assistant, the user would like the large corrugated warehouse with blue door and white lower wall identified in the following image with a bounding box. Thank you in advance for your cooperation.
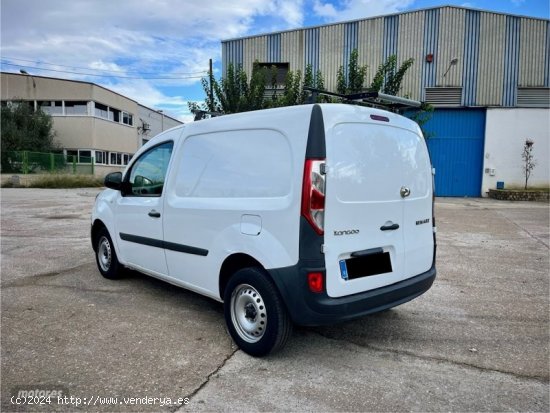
[222,6,550,196]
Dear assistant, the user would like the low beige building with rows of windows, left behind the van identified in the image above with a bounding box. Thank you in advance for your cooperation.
[0,72,182,175]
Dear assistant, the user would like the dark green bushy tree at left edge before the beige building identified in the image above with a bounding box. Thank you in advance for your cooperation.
[0,101,59,153]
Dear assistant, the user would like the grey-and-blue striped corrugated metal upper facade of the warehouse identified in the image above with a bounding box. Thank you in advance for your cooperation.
[222,6,550,107]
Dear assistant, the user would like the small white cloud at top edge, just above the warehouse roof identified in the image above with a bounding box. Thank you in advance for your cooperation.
[313,0,414,22]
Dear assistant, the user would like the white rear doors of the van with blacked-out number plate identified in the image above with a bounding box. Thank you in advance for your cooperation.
[324,114,433,297]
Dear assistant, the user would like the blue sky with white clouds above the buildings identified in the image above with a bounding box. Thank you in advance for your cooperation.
[0,0,550,121]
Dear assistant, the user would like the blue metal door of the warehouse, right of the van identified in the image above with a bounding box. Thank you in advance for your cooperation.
[425,109,485,197]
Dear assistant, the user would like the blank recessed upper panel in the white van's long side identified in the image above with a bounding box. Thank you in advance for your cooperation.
[176,129,292,198]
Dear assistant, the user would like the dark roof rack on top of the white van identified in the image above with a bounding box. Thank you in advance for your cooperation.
[304,87,422,110]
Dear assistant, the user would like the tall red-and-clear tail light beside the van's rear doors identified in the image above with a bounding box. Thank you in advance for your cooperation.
[302,159,325,235]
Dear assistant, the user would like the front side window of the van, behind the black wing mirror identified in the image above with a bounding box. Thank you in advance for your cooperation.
[129,142,174,196]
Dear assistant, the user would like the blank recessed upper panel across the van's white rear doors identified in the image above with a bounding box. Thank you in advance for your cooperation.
[327,123,431,202]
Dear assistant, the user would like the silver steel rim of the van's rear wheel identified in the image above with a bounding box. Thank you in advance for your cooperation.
[230,284,267,343]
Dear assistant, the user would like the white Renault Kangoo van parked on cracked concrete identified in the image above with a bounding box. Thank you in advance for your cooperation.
[91,104,436,356]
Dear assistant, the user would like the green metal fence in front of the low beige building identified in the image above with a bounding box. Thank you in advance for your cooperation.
[0,151,95,175]
